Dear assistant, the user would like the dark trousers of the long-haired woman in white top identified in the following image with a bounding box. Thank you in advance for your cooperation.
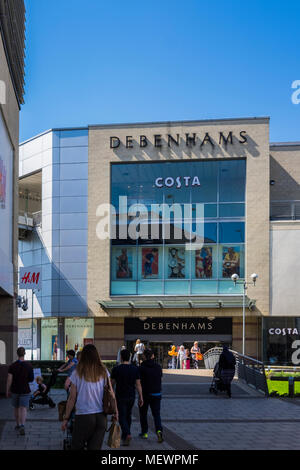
[72,413,107,450]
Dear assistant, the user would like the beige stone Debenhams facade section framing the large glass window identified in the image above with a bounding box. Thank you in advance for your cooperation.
[88,118,270,366]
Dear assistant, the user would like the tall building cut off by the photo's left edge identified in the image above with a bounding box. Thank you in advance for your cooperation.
[0,0,25,364]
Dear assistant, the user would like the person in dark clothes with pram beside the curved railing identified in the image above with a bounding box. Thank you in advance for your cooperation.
[210,346,236,398]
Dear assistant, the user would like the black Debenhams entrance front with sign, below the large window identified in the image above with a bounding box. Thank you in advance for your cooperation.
[124,317,232,368]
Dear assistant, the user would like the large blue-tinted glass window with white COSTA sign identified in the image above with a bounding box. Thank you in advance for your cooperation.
[111,159,246,295]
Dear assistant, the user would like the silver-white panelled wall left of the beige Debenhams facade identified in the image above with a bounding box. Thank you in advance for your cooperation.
[19,129,88,319]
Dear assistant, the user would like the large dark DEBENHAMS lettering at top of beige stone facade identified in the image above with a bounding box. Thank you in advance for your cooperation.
[110,131,247,149]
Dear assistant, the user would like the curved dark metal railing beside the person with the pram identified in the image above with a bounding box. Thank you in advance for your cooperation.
[203,348,269,396]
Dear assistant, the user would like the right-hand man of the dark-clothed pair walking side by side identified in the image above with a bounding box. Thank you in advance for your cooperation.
[140,349,163,442]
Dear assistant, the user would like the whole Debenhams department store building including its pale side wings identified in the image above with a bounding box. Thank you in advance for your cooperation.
[19,118,300,365]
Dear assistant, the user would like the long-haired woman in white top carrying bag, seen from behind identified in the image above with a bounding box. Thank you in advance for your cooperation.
[62,344,118,450]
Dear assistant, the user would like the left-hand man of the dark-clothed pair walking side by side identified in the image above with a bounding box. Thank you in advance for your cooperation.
[110,349,143,446]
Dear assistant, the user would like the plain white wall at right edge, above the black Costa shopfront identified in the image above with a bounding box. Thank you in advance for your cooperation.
[270,221,300,317]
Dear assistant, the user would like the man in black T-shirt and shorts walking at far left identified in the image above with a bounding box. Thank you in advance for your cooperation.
[6,348,34,436]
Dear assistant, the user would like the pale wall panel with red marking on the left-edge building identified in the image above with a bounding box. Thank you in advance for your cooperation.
[0,113,14,295]
